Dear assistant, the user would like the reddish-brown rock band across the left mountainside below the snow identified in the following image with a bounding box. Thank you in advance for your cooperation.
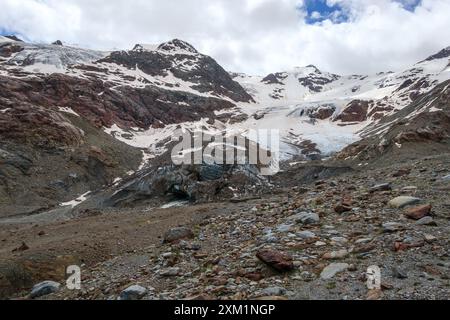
[0,74,234,132]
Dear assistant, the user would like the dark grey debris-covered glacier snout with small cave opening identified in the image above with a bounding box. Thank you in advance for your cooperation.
[100,164,267,206]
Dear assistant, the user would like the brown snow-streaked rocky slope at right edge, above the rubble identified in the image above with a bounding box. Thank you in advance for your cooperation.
[338,81,450,160]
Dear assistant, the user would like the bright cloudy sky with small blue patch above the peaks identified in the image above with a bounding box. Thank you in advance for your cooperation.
[0,0,450,75]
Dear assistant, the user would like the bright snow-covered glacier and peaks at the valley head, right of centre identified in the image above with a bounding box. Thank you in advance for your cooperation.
[232,49,450,158]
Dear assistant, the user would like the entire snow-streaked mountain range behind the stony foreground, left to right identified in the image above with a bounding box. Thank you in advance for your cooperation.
[0,37,450,215]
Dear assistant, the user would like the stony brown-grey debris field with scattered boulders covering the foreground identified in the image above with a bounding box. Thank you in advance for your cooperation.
[0,154,450,300]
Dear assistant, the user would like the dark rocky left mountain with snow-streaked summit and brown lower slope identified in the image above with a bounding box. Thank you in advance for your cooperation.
[0,38,252,215]
